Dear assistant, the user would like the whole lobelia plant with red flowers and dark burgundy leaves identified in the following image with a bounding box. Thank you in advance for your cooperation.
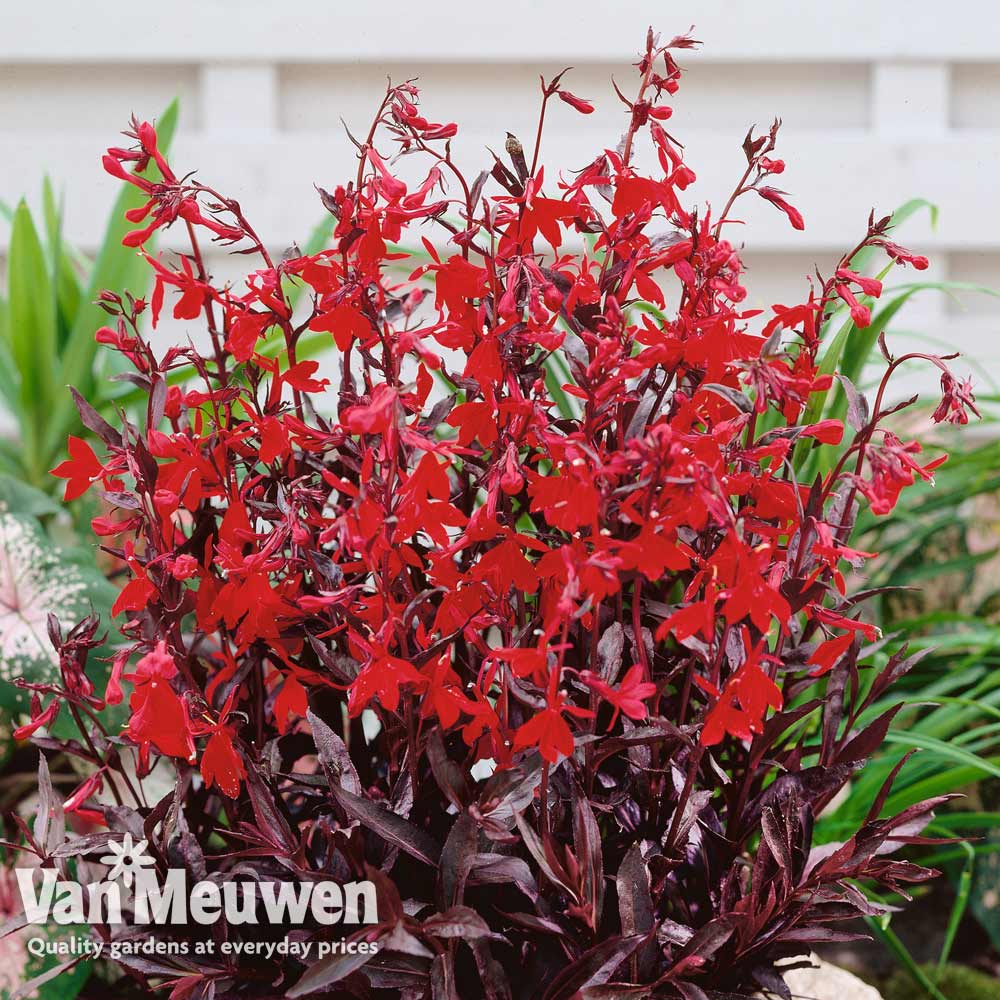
[3,32,973,1000]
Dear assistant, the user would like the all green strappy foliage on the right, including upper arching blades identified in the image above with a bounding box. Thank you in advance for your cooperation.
[772,199,1000,1000]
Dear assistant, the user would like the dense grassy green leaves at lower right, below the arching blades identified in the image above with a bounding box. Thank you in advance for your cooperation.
[825,428,1000,1000]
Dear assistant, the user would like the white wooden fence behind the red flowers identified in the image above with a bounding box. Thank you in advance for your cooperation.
[0,0,1000,402]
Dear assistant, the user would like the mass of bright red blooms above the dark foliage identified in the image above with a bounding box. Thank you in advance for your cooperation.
[43,37,972,794]
